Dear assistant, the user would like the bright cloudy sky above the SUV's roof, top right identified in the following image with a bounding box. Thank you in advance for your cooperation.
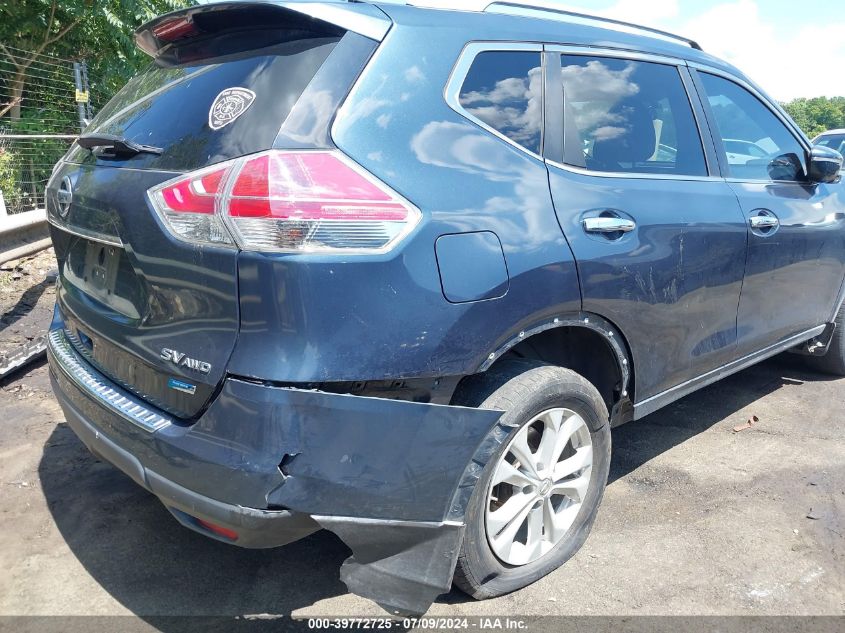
[536,0,845,101]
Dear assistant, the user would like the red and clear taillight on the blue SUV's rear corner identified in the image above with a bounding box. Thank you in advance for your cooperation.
[150,150,420,253]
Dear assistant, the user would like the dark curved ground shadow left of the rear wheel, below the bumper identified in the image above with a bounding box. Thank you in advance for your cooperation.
[38,424,350,630]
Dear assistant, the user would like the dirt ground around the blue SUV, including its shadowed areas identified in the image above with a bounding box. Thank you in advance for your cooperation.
[0,260,845,618]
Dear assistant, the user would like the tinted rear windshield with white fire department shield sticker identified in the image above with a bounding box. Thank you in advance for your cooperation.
[70,36,340,170]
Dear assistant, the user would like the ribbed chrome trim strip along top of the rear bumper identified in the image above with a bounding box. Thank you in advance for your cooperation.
[47,330,173,433]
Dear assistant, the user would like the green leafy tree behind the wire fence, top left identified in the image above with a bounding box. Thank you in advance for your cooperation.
[0,0,194,122]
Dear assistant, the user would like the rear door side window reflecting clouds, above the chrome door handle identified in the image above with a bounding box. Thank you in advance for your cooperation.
[561,55,707,176]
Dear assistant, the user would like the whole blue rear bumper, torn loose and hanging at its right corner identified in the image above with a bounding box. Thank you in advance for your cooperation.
[48,319,508,613]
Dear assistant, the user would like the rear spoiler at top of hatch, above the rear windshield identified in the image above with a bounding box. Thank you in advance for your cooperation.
[135,0,391,57]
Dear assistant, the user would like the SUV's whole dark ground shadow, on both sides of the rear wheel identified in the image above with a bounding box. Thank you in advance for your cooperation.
[38,357,825,631]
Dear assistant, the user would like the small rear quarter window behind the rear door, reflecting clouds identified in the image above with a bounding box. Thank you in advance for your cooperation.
[458,51,543,154]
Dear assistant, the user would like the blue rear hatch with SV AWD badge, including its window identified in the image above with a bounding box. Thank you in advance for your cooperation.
[47,3,366,418]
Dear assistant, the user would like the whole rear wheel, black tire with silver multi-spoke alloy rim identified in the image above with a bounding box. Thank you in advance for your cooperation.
[455,360,610,599]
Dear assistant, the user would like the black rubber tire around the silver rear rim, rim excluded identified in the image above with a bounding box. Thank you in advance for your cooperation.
[454,360,610,600]
